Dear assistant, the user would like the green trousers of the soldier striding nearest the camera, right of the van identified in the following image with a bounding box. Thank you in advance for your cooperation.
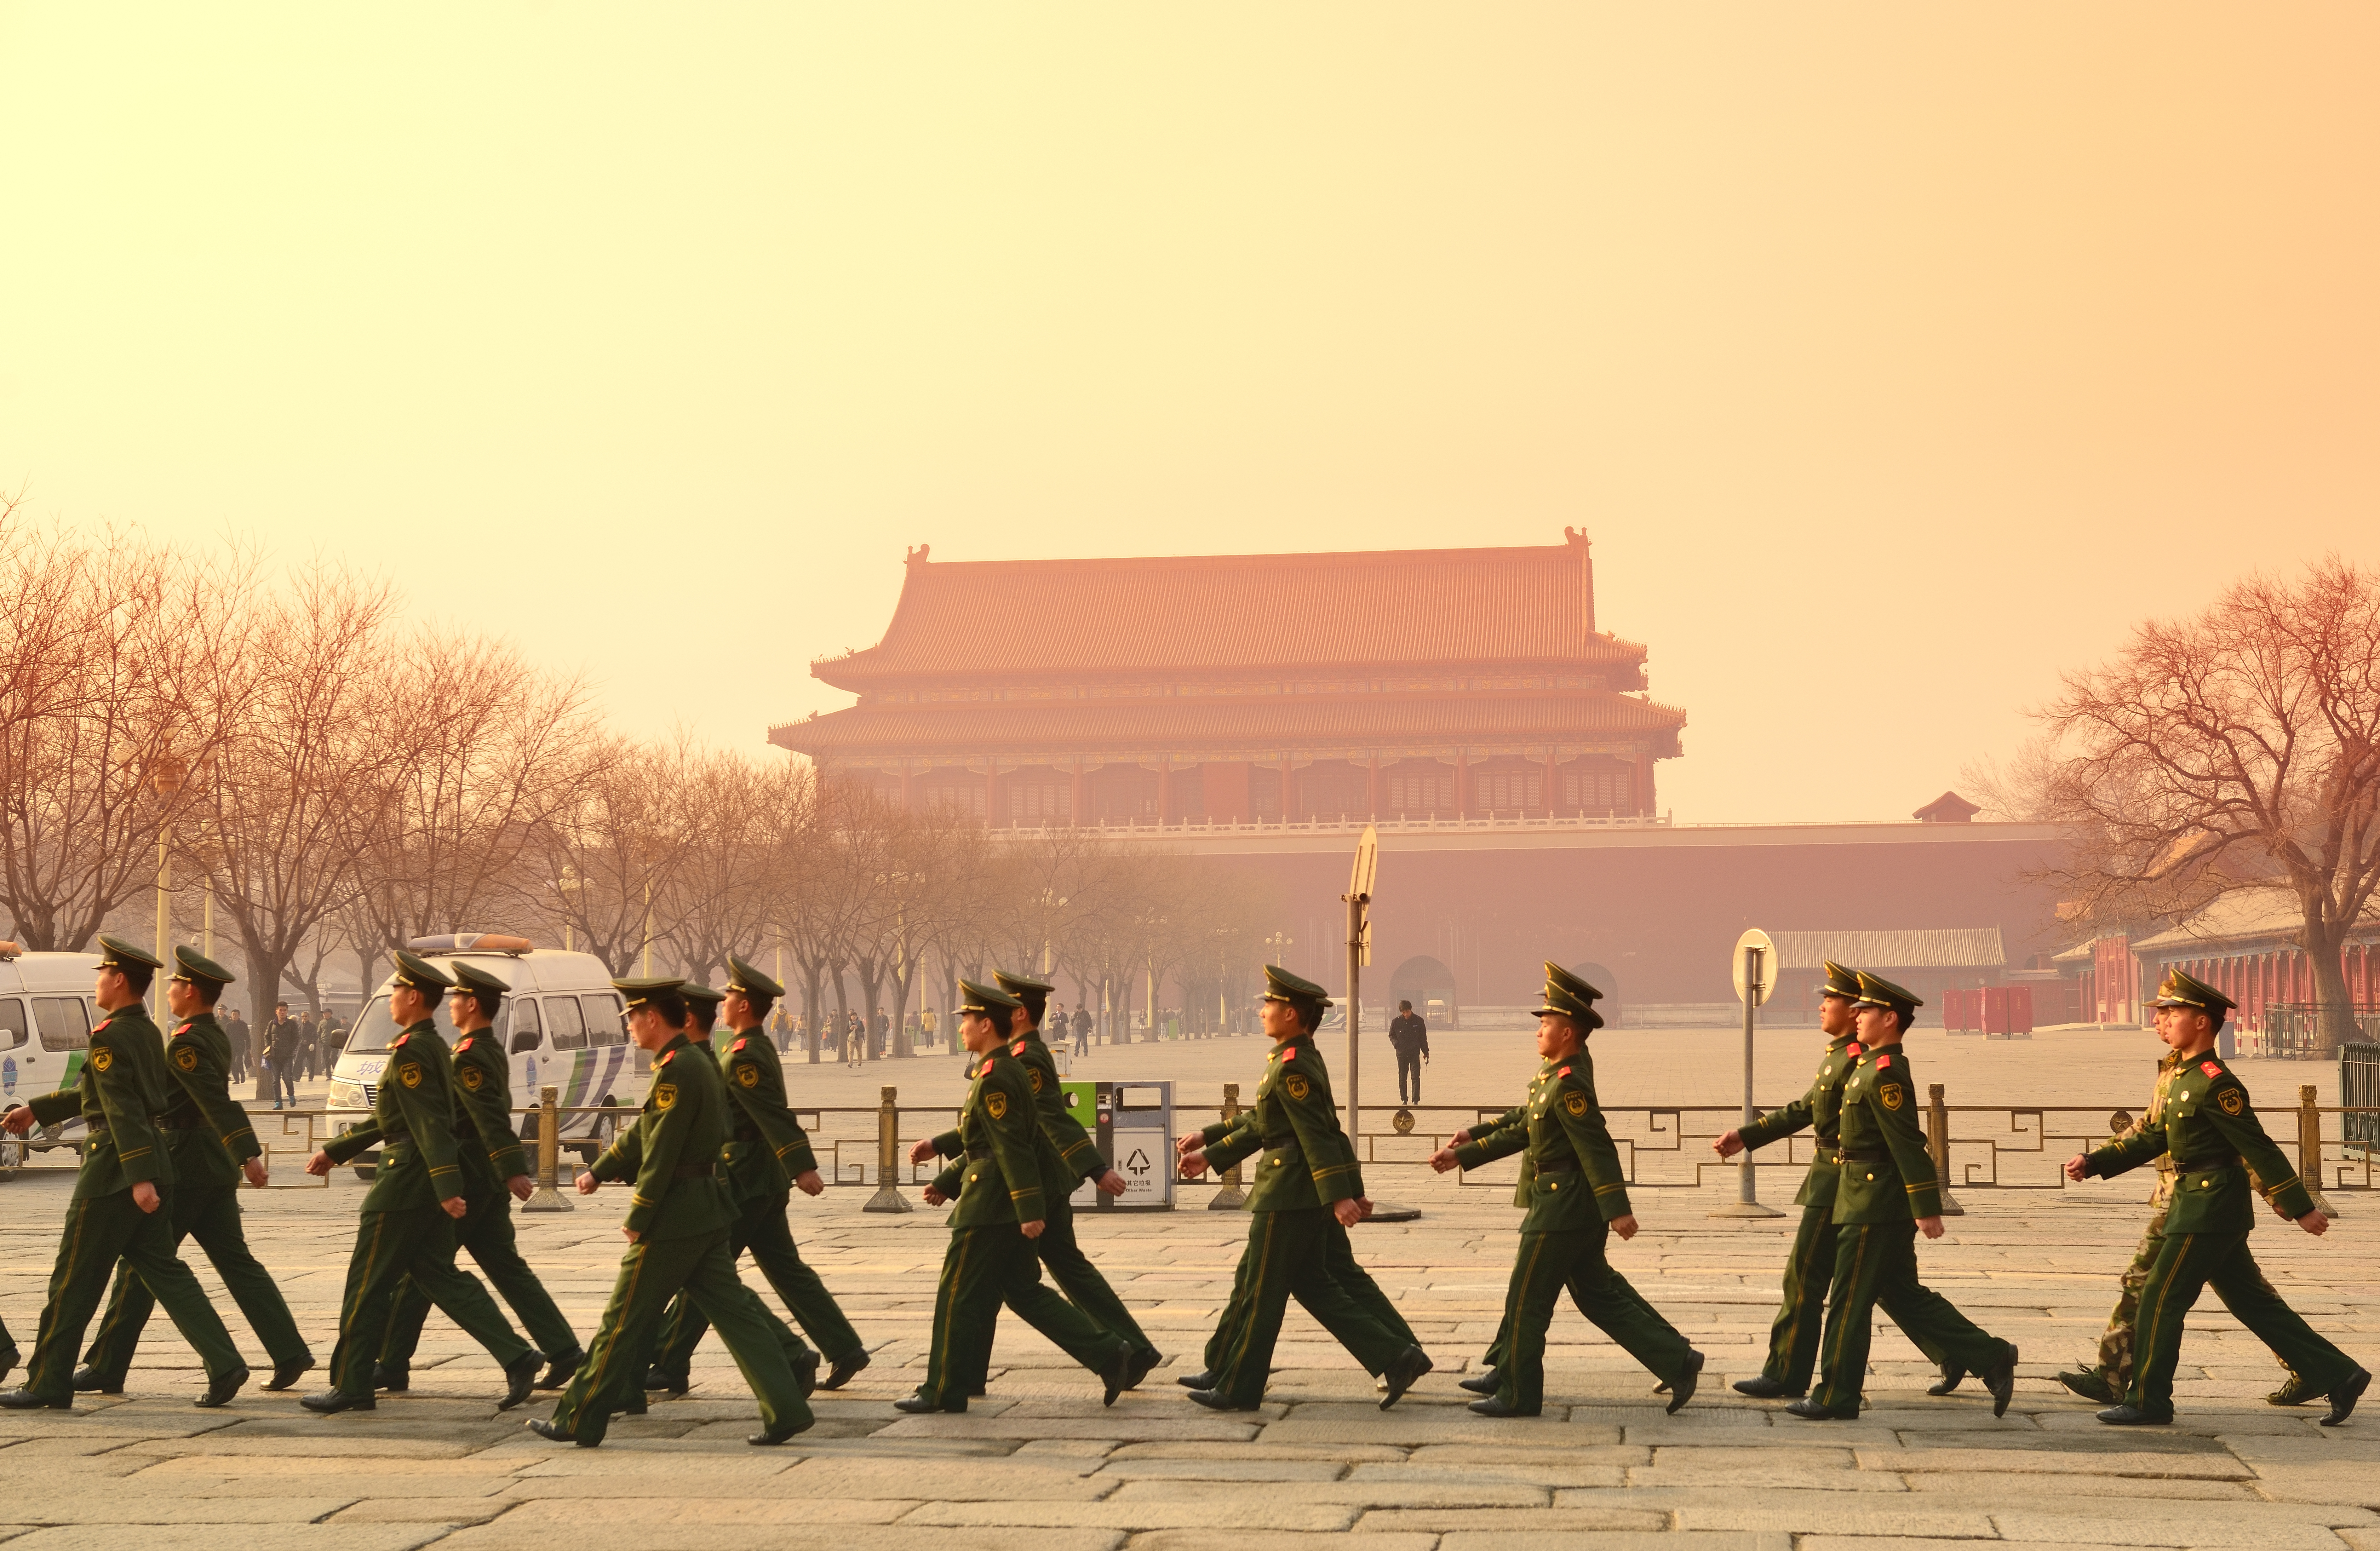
[555,1228,809,1444]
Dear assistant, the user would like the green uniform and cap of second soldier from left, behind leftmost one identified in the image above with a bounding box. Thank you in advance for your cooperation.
[76,947,314,1394]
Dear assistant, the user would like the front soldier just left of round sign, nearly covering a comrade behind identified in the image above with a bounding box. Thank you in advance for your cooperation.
[1430,964,1704,1415]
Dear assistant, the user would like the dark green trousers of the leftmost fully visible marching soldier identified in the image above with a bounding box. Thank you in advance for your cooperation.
[24,1189,240,1403]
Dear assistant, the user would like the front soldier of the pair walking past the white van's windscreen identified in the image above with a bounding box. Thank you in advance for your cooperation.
[300,949,540,1415]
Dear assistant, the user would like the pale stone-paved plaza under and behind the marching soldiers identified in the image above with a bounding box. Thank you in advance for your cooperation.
[0,1033,2380,1551]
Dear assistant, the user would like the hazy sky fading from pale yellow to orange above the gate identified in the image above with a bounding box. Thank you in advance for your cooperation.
[0,0,2380,821]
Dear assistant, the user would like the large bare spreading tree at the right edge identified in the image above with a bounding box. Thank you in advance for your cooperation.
[2044,557,2380,1049]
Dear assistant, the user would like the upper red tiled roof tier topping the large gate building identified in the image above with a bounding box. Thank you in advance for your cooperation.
[809,530,1645,690]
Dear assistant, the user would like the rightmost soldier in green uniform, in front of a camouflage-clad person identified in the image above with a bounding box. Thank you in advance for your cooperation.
[2066,971,2373,1427]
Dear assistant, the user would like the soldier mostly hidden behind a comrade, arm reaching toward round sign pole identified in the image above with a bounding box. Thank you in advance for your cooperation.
[1711,959,1966,1401]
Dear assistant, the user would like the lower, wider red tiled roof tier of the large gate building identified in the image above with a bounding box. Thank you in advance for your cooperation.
[769,695,1685,761]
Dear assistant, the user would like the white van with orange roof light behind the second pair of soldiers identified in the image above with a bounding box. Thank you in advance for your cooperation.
[328,932,647,1180]
